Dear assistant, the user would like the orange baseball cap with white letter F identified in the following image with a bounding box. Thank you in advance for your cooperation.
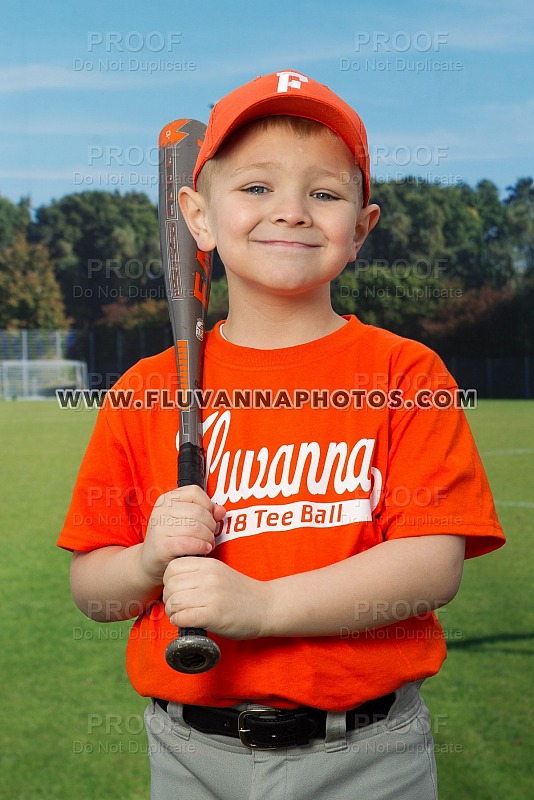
[193,70,371,206]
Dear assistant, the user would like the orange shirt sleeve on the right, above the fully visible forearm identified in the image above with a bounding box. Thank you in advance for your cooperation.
[377,342,505,558]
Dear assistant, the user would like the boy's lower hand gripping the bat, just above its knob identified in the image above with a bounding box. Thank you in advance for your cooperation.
[163,558,270,639]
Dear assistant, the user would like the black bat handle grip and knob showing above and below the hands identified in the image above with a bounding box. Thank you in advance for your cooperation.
[165,442,221,674]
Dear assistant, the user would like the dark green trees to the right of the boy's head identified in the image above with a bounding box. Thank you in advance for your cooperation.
[332,178,534,356]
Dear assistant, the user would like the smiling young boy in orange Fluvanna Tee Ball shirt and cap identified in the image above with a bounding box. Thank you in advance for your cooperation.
[59,71,504,800]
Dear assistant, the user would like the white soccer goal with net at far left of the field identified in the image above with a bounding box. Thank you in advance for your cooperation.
[0,359,88,400]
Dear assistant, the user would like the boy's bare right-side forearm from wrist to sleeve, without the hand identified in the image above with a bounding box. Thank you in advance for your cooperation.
[264,534,465,636]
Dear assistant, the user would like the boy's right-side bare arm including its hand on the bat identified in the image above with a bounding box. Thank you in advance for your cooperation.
[163,534,465,639]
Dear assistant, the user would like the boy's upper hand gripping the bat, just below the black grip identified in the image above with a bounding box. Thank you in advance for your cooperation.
[141,486,226,586]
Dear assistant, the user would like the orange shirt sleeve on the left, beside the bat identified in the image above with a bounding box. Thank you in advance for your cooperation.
[57,406,143,552]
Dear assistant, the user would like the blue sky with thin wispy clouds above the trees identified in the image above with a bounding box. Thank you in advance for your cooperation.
[0,0,534,212]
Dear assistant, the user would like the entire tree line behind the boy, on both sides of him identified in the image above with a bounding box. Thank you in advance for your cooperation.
[0,177,534,356]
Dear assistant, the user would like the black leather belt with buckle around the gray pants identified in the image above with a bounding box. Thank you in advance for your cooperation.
[156,692,395,750]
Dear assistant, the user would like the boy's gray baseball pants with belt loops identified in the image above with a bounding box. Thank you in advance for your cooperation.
[145,681,438,800]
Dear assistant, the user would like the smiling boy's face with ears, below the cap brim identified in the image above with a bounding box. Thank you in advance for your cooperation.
[182,127,379,296]
